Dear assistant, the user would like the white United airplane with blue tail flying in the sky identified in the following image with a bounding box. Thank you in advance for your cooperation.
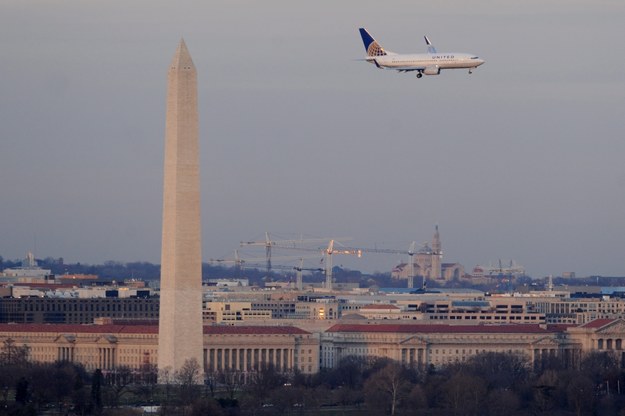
[359,27,484,78]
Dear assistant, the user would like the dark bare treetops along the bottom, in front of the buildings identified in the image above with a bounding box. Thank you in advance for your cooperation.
[0,344,625,416]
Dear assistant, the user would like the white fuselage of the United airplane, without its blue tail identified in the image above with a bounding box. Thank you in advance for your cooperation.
[367,53,484,71]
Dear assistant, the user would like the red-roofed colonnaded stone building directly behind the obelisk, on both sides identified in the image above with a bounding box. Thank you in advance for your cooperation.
[0,323,319,374]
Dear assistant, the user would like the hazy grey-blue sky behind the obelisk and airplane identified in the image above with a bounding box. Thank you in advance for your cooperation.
[0,0,625,277]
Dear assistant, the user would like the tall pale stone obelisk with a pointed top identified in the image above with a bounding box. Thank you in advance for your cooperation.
[158,40,203,381]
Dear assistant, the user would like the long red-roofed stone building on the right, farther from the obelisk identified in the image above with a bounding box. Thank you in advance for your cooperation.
[321,320,625,369]
